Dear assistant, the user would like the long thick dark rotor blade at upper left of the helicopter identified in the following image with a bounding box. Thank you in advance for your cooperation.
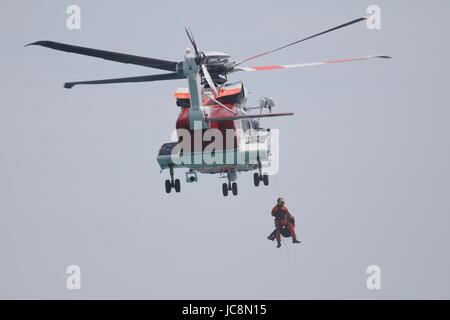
[27,41,177,71]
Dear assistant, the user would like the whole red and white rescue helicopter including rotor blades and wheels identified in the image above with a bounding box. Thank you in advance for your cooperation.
[27,16,390,196]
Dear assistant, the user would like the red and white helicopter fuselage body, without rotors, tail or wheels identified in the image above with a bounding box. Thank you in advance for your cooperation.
[157,83,270,176]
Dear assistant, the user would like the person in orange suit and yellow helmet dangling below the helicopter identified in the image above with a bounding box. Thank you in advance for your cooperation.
[267,198,300,248]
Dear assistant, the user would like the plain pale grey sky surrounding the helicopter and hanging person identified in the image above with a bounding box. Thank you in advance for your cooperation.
[0,0,450,299]
